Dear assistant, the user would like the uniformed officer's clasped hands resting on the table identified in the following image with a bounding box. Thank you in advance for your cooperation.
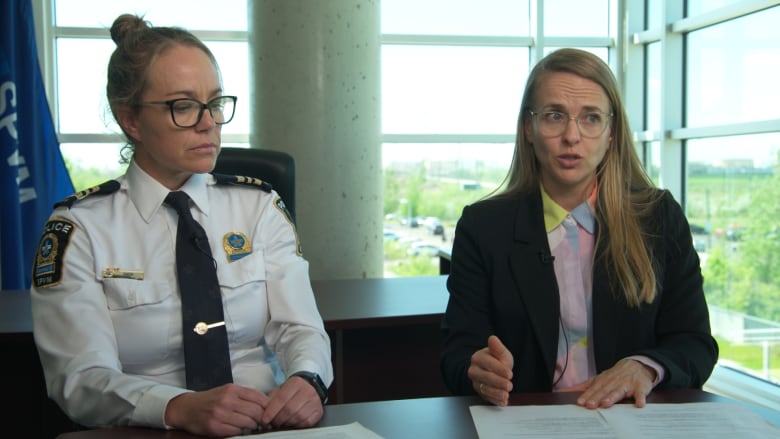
[165,376,324,436]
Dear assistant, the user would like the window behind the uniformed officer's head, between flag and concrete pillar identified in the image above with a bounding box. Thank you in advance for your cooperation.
[38,0,251,190]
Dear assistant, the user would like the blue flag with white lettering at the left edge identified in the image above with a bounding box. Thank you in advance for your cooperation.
[0,0,74,289]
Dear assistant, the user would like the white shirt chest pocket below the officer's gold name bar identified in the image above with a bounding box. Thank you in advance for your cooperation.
[103,279,175,373]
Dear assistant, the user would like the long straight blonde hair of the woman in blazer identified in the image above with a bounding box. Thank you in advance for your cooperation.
[494,49,660,307]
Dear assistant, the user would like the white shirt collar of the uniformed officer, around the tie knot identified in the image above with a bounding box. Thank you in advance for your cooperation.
[125,160,209,223]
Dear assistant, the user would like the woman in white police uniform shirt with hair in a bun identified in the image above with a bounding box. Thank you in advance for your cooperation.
[32,15,333,436]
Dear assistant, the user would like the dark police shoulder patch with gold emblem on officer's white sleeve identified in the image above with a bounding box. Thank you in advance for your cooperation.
[32,218,76,288]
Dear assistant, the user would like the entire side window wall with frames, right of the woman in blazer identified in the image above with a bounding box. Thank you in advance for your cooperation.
[626,0,780,402]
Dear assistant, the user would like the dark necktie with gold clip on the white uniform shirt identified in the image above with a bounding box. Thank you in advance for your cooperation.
[165,192,233,391]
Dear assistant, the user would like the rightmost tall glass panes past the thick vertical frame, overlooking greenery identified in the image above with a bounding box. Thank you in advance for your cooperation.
[684,7,780,383]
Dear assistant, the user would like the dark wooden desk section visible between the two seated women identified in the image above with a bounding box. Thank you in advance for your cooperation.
[312,276,450,403]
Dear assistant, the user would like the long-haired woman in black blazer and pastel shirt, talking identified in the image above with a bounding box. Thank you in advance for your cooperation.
[441,49,718,408]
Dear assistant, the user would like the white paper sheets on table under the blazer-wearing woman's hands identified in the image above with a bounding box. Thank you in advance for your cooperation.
[470,402,780,439]
